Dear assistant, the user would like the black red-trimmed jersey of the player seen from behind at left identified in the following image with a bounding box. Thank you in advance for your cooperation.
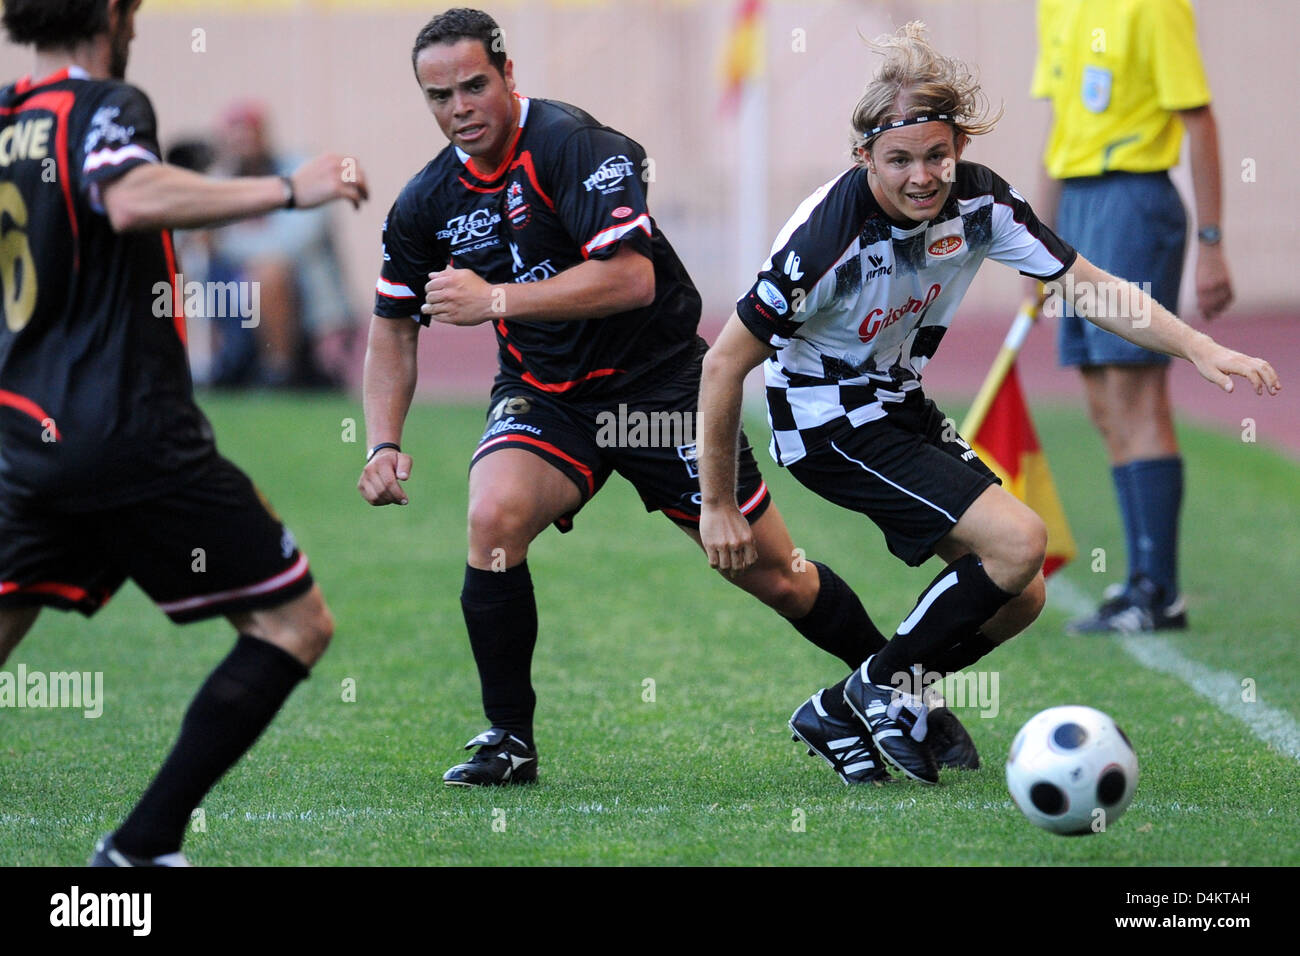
[0,68,215,511]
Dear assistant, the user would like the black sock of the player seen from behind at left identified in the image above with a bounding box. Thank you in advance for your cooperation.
[113,633,307,857]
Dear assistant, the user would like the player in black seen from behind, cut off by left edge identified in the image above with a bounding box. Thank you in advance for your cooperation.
[0,0,365,866]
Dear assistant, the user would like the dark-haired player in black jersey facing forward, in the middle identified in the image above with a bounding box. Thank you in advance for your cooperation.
[359,9,974,786]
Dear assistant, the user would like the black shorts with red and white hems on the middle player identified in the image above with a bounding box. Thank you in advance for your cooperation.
[469,343,772,531]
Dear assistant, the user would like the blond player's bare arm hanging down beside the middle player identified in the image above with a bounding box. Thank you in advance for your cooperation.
[696,312,772,572]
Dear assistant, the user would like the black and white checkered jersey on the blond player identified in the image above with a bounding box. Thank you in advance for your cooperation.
[736,163,1076,464]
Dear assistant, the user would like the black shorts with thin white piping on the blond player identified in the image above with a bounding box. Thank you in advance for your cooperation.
[789,389,1002,567]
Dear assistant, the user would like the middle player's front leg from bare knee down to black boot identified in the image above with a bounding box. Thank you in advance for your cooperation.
[442,449,582,787]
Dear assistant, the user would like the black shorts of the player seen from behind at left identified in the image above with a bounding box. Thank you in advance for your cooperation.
[0,457,312,623]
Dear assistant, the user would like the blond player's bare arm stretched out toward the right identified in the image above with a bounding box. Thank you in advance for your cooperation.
[1047,256,1282,395]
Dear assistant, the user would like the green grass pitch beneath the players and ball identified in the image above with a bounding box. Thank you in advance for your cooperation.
[0,397,1300,866]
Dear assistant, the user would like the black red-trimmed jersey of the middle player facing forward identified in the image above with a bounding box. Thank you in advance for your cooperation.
[374,98,701,401]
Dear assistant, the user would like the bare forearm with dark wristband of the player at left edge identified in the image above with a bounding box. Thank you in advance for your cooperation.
[103,153,369,233]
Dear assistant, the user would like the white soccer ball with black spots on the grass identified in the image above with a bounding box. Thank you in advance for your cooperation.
[1006,706,1138,836]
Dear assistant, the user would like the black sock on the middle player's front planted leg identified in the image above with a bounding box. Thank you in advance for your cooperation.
[460,561,537,747]
